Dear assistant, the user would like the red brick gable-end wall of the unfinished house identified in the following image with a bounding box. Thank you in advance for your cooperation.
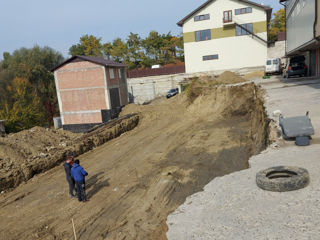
[56,61,107,124]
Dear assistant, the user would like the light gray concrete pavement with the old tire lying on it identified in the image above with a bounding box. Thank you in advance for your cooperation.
[167,77,320,240]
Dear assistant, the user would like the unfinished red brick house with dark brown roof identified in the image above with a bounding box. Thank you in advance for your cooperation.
[52,56,128,132]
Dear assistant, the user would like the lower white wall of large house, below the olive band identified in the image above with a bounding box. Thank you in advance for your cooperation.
[184,35,267,73]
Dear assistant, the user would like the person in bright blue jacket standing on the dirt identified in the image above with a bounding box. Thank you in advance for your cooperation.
[71,159,88,202]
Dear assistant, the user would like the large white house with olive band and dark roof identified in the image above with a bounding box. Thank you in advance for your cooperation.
[177,0,272,73]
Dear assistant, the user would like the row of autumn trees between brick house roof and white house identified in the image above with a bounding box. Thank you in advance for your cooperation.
[69,31,184,70]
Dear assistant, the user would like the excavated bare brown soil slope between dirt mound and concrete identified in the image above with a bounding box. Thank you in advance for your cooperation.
[0,74,268,240]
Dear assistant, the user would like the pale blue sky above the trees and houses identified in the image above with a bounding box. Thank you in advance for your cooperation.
[0,0,282,59]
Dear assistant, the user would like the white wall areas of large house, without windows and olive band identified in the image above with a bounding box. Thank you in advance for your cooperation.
[183,0,268,73]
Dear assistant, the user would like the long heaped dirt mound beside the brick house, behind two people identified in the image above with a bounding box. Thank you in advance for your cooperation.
[0,115,139,192]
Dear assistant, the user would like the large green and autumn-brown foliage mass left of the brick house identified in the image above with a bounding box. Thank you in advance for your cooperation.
[0,46,63,132]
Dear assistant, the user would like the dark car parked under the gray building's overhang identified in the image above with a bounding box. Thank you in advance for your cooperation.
[283,56,308,78]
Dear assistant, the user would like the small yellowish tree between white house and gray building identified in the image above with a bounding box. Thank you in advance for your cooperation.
[268,8,286,42]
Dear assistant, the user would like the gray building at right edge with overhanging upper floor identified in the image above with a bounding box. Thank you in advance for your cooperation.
[280,0,320,76]
